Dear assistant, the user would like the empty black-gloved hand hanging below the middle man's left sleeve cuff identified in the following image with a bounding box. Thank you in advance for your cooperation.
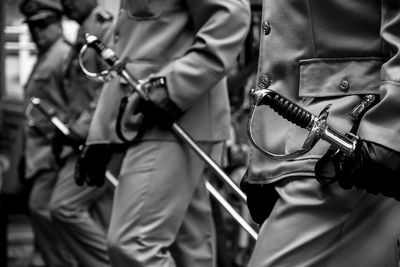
[74,144,112,187]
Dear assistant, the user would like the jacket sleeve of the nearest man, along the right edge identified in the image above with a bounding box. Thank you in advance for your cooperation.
[359,0,400,151]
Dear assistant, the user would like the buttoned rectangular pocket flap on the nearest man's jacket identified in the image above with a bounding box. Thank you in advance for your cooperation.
[299,57,384,97]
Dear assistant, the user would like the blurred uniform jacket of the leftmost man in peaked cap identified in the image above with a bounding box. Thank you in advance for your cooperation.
[25,38,70,178]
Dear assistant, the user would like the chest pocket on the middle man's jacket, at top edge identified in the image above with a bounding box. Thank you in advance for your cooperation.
[126,0,165,19]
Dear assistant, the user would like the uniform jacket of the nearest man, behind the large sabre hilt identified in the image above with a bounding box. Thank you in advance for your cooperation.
[250,0,400,183]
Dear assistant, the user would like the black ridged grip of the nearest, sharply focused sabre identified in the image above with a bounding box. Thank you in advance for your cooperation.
[259,91,314,128]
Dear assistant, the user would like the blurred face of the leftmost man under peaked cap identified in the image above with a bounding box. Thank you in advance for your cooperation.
[28,20,62,52]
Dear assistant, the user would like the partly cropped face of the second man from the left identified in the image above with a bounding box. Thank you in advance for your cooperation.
[61,0,96,23]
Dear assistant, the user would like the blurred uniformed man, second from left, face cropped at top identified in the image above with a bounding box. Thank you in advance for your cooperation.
[50,0,113,267]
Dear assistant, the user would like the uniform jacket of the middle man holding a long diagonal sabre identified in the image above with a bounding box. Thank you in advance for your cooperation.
[88,0,250,143]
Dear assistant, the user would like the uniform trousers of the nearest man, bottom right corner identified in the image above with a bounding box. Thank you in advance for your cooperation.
[248,177,400,267]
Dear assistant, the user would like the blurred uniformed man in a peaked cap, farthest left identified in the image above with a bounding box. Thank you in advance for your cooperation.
[20,0,75,266]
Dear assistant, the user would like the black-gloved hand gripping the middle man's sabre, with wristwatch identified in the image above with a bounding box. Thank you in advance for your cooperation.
[135,77,183,129]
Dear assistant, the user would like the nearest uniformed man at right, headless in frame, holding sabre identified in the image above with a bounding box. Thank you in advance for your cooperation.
[243,0,400,267]
